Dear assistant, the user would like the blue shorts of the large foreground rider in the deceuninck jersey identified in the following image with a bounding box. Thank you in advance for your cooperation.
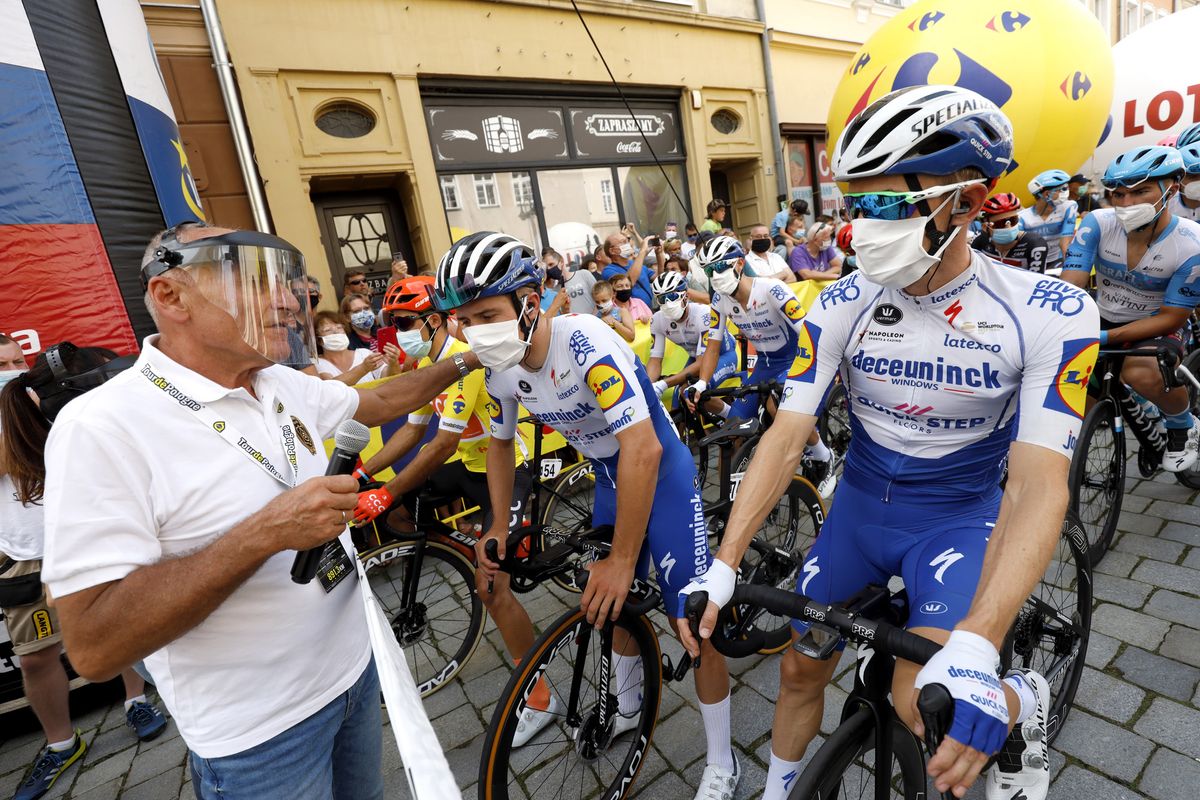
[792,481,1001,634]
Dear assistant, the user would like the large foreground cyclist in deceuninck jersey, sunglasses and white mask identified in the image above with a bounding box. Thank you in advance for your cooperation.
[685,86,1098,800]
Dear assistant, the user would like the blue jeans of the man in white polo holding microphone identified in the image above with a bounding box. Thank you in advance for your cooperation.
[188,660,383,800]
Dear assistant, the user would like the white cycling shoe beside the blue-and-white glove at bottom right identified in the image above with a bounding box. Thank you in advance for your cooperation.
[986,669,1050,800]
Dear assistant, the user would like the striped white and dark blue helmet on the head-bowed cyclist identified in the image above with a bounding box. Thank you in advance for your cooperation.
[433,230,546,311]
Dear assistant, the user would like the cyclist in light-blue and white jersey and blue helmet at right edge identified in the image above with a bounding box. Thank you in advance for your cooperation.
[1062,146,1200,473]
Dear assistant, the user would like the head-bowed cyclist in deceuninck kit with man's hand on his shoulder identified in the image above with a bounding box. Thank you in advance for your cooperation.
[433,231,739,800]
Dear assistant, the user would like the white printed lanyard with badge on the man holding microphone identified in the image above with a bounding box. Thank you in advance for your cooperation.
[142,362,354,594]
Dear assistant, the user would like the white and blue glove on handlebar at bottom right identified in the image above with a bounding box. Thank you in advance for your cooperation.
[916,631,1008,756]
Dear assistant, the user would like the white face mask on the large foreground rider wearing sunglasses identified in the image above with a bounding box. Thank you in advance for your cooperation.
[852,192,962,289]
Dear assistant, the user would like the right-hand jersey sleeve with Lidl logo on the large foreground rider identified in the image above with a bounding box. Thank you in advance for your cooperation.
[1016,289,1100,458]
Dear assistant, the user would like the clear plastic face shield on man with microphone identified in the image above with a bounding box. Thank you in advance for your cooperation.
[142,230,317,368]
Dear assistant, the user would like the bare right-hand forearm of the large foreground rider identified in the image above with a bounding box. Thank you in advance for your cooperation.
[958,453,1068,649]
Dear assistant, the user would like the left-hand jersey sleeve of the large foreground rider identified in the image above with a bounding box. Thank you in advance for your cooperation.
[779,272,866,415]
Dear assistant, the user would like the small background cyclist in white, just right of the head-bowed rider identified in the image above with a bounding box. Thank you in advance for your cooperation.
[646,272,738,415]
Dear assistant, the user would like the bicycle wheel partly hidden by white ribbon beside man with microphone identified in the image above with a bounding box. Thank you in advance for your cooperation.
[359,540,484,697]
